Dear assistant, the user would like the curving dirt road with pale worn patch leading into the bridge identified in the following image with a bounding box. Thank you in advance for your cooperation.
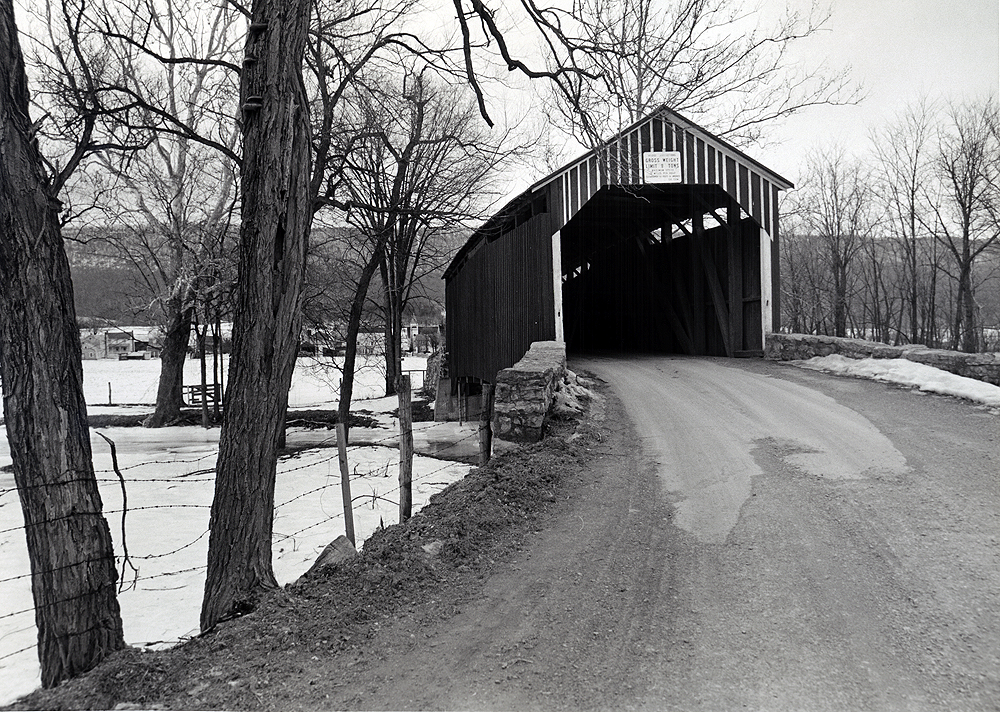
[331,358,1000,710]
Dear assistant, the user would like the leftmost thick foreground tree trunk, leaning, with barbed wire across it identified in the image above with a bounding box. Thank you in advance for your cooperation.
[0,0,125,687]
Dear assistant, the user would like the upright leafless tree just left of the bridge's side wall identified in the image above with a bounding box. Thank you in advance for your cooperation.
[343,72,521,394]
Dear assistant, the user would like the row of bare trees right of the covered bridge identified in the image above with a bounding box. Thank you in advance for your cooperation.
[781,97,1000,352]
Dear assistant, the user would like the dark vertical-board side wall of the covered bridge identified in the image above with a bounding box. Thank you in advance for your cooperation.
[446,214,556,383]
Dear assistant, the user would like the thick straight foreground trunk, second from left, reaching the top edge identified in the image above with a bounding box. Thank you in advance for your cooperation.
[201,0,312,630]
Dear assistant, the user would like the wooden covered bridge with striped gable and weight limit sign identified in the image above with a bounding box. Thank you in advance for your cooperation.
[444,108,792,394]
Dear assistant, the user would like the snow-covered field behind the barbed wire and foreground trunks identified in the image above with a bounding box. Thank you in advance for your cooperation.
[0,358,478,704]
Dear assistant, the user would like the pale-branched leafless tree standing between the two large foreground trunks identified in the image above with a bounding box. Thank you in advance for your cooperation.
[98,0,243,427]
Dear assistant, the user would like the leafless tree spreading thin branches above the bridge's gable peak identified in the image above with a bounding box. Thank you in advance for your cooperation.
[547,0,860,148]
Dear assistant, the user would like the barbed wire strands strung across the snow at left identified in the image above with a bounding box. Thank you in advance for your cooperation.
[0,423,479,664]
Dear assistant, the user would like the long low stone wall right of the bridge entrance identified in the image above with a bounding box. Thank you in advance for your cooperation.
[764,334,1000,386]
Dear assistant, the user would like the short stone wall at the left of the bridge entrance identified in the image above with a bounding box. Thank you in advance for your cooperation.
[492,341,566,442]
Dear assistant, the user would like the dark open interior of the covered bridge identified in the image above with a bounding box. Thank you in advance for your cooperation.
[561,185,763,356]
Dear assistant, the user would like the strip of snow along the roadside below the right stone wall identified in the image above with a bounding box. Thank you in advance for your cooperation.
[794,354,1000,408]
